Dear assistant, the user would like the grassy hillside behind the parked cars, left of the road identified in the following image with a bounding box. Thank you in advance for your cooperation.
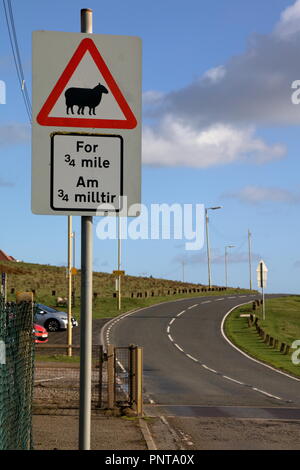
[0,262,253,318]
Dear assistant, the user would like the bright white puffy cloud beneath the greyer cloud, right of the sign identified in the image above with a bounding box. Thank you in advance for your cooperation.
[143,115,285,168]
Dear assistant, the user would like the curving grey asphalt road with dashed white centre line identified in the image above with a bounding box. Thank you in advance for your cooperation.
[103,295,300,419]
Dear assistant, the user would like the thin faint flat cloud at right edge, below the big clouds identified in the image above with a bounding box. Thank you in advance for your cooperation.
[223,185,300,204]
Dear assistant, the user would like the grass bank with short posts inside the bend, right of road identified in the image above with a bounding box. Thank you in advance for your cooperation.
[224,296,300,377]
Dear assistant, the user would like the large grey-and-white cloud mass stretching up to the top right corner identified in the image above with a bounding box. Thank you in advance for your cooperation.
[143,0,300,168]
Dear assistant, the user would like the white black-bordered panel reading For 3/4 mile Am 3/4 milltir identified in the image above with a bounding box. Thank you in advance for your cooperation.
[50,133,123,212]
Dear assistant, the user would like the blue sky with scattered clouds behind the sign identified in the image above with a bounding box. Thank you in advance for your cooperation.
[0,0,300,293]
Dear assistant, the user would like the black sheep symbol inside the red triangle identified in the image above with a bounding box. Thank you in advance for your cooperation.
[65,83,108,115]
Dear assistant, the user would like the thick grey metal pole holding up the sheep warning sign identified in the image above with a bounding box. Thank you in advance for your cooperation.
[79,8,93,450]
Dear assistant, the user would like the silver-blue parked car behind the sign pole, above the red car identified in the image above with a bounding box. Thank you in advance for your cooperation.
[34,304,78,332]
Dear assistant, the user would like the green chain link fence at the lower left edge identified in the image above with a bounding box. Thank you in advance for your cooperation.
[0,296,34,450]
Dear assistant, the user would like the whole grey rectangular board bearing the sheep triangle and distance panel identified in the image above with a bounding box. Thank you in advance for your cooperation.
[32,31,141,215]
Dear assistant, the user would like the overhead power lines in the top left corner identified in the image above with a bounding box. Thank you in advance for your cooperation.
[3,0,32,123]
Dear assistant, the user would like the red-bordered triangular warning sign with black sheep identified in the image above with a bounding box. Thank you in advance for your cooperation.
[36,38,137,129]
